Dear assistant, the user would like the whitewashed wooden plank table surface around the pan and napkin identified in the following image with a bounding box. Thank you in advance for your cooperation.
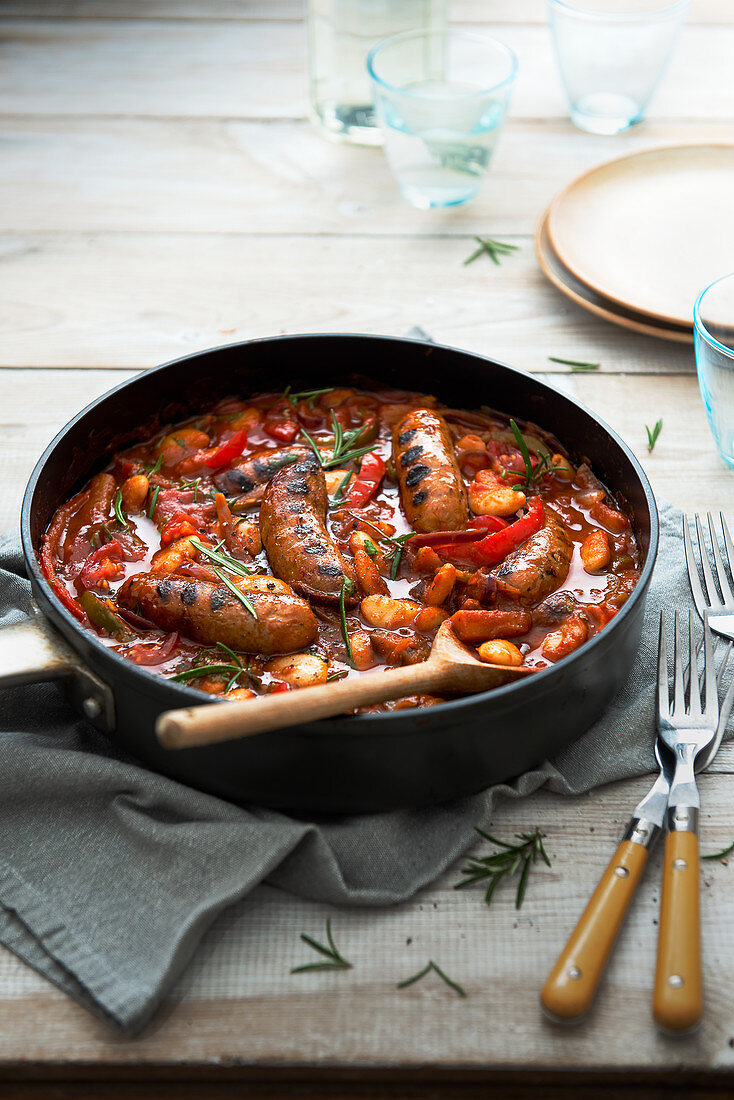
[0,0,734,1097]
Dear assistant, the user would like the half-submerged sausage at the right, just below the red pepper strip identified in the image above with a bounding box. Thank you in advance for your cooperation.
[493,508,573,604]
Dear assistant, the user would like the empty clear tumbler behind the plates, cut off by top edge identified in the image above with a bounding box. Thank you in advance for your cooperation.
[548,0,689,134]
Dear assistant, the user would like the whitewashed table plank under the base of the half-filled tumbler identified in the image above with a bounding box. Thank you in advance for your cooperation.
[5,117,732,237]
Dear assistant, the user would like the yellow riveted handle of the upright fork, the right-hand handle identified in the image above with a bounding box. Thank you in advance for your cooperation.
[653,832,703,1032]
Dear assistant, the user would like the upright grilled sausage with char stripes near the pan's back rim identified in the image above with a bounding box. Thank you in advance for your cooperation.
[393,408,469,532]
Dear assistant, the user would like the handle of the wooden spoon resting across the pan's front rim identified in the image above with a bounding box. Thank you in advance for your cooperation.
[155,661,451,749]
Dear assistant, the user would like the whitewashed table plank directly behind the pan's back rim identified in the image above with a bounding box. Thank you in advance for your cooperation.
[0,232,693,373]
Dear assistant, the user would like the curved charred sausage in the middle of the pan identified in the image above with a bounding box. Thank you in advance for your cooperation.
[260,454,360,604]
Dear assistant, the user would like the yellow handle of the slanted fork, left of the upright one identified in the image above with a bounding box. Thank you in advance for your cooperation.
[540,840,648,1022]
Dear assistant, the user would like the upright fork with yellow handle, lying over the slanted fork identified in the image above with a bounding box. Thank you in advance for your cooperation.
[653,608,719,1032]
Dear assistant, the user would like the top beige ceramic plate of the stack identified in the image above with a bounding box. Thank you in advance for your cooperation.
[548,144,734,325]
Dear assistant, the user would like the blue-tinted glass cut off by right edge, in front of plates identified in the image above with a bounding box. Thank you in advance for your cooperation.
[693,274,734,468]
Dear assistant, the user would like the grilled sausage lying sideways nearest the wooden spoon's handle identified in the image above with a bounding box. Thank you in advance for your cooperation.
[118,573,318,653]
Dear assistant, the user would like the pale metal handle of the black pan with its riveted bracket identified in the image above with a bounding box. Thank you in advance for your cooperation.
[0,603,114,733]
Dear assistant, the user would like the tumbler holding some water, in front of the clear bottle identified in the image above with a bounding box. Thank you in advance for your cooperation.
[368,31,517,210]
